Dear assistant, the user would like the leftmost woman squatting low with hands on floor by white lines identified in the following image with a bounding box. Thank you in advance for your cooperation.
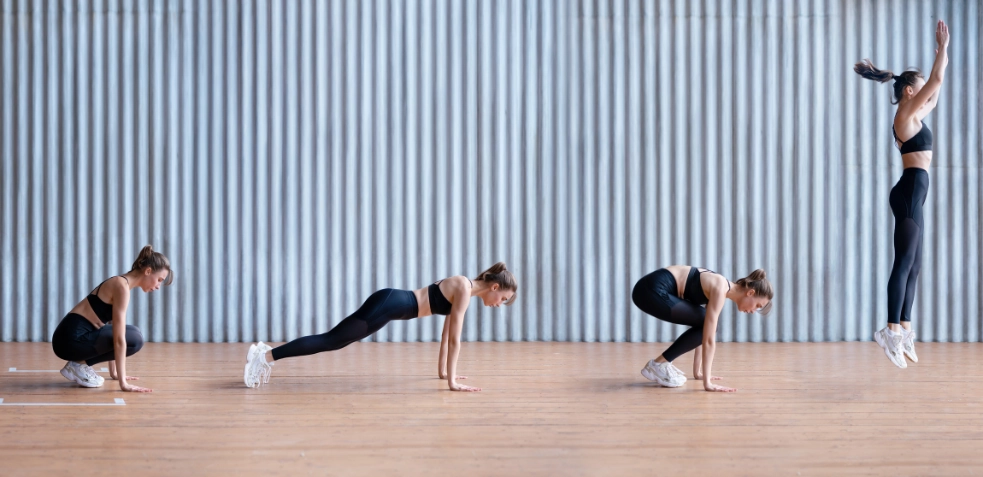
[51,245,174,393]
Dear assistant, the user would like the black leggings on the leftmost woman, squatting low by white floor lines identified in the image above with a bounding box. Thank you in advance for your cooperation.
[51,313,143,366]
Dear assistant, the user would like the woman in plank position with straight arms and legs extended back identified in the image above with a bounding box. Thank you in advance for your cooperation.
[243,262,519,391]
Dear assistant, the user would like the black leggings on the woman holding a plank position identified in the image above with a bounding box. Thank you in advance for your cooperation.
[272,288,419,360]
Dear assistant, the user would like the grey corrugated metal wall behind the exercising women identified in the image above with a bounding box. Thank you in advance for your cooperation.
[0,0,983,341]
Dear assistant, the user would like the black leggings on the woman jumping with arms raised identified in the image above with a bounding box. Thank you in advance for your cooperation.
[887,167,929,324]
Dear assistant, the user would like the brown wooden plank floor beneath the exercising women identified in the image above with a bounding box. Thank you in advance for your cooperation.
[0,343,983,476]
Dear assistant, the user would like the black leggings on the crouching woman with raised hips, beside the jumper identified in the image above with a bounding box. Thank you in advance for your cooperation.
[631,268,707,362]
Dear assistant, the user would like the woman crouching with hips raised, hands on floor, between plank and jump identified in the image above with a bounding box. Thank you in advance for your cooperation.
[631,265,774,392]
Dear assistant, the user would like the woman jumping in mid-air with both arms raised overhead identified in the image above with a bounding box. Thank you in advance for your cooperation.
[853,20,949,368]
